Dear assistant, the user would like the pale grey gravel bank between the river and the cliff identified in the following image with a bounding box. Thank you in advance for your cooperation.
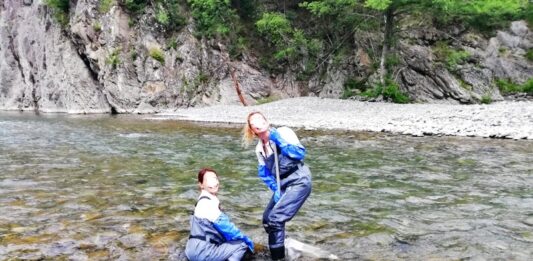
[151,97,533,140]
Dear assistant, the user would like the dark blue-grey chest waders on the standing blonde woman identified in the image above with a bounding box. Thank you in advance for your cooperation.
[263,145,311,260]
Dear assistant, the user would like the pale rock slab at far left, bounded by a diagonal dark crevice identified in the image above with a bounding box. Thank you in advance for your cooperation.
[0,0,110,113]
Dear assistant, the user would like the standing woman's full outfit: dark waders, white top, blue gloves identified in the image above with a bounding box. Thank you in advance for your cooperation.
[256,128,312,260]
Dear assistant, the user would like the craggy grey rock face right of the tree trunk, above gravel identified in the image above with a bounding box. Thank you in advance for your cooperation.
[398,21,533,103]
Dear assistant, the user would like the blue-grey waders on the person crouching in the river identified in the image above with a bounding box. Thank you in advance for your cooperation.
[185,196,248,261]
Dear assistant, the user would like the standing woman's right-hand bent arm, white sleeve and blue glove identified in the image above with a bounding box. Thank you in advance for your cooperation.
[269,127,306,160]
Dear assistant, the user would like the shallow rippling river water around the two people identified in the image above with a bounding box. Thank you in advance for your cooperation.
[0,113,533,260]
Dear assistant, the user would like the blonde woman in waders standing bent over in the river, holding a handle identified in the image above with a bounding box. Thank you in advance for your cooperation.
[243,112,311,260]
